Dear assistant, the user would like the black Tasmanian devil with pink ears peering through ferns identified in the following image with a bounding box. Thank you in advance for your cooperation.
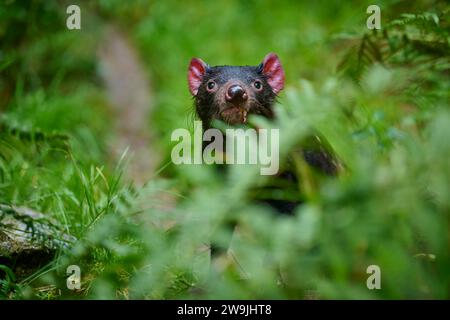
[188,53,338,258]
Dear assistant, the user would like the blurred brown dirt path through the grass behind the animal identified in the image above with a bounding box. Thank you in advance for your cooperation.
[98,27,158,185]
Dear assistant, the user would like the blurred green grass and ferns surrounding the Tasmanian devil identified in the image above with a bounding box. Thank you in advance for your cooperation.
[0,1,450,299]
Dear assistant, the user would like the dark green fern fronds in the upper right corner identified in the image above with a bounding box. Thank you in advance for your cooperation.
[340,8,450,108]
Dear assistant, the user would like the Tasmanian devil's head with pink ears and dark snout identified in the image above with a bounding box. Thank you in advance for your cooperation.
[188,53,284,127]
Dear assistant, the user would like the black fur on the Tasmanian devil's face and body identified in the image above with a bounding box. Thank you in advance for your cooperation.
[188,57,338,255]
